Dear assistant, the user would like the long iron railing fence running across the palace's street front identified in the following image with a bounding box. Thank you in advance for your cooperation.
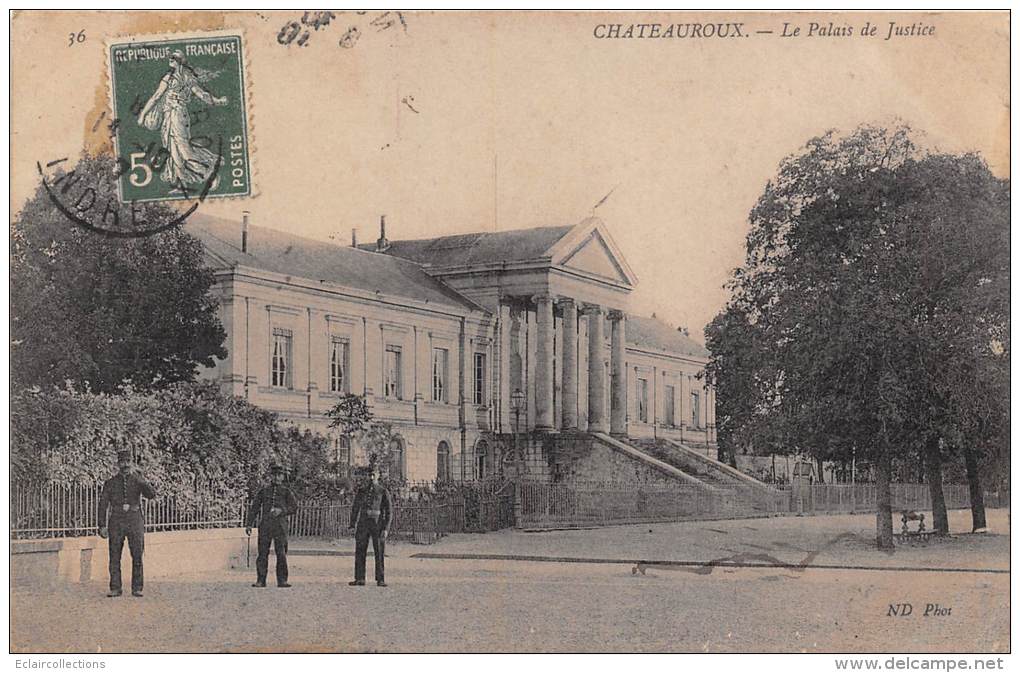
[10,480,1010,542]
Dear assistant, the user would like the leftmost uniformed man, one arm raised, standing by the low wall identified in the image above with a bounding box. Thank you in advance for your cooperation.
[98,451,156,599]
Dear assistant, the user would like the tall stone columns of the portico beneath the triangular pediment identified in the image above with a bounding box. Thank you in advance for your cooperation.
[505,293,627,434]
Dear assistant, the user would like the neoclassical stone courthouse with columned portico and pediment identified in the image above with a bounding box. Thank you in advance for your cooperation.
[187,215,715,479]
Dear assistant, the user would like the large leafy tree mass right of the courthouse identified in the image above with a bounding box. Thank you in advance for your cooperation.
[708,126,1009,547]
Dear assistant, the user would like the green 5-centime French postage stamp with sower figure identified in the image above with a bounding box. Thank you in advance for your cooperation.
[108,33,252,203]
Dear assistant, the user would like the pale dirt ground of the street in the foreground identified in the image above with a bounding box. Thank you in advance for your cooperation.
[11,511,1009,653]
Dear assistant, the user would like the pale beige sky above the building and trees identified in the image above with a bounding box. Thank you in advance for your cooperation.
[10,10,1009,339]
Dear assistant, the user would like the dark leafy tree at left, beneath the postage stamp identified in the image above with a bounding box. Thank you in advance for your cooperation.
[10,156,225,392]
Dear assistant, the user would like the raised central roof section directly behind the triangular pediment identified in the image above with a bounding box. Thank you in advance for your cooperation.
[359,225,573,267]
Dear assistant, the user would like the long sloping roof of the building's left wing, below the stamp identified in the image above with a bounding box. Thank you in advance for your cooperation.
[185,213,483,311]
